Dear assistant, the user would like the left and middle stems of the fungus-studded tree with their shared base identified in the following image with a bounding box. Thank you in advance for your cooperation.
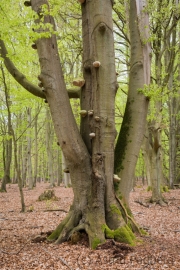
[31,0,133,248]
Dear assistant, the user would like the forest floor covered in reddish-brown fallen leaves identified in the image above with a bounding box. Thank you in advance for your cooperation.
[0,183,180,270]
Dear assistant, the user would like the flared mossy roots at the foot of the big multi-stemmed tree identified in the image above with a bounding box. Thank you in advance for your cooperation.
[47,197,138,249]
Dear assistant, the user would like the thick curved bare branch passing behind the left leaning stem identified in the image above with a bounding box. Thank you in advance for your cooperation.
[0,40,81,99]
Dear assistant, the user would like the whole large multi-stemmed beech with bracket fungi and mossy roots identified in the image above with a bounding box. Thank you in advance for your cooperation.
[0,0,149,248]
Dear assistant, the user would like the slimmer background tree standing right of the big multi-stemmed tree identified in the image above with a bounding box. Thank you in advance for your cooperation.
[142,1,178,201]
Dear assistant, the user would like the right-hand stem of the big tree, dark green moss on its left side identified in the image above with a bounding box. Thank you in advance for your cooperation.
[114,0,151,206]
